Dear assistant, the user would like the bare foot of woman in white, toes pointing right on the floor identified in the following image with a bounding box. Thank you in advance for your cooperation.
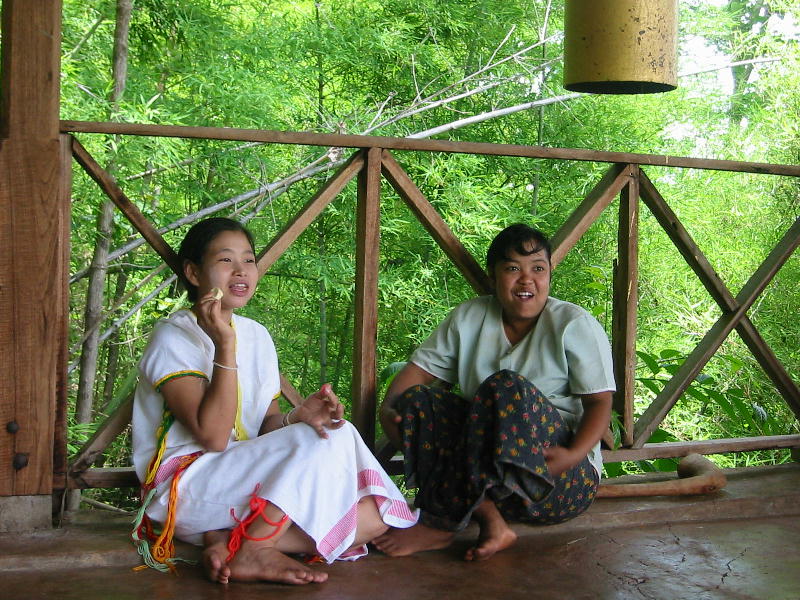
[229,546,328,585]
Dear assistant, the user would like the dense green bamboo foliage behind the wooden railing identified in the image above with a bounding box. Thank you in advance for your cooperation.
[61,0,800,506]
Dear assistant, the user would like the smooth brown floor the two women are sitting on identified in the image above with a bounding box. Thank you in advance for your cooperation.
[0,464,800,600]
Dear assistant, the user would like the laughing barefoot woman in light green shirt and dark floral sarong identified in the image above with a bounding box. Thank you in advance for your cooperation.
[374,224,615,560]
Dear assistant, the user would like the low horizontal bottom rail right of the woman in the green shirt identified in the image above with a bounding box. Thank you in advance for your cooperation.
[602,435,800,462]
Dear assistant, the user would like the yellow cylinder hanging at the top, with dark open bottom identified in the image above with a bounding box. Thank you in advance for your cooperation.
[564,0,678,94]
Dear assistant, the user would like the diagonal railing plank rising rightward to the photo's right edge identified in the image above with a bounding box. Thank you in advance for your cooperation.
[633,218,800,448]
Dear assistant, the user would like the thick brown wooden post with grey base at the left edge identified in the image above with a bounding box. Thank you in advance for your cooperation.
[0,0,69,531]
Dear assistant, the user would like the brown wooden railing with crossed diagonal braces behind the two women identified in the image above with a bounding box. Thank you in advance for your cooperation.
[54,121,800,489]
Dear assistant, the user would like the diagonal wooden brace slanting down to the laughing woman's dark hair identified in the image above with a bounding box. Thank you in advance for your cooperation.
[382,151,492,294]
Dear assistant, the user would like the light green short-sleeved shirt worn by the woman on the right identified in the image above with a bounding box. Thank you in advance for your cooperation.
[410,296,616,473]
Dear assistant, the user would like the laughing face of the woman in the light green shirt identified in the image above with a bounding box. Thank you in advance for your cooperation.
[494,243,551,331]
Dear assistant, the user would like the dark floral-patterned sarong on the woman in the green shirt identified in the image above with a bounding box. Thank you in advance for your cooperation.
[396,370,599,531]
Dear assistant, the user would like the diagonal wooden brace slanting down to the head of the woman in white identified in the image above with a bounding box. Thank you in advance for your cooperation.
[72,138,183,276]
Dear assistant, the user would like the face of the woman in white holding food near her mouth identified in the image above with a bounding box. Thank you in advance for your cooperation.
[184,231,258,312]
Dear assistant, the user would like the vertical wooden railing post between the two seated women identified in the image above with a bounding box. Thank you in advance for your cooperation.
[353,148,381,449]
